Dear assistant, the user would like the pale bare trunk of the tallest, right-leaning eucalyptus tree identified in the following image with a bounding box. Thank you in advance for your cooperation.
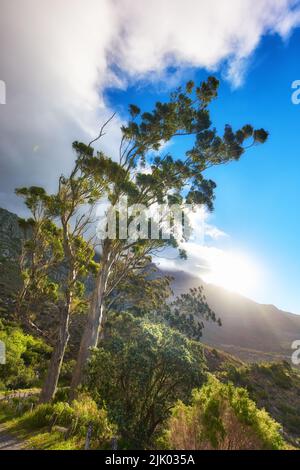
[70,246,112,398]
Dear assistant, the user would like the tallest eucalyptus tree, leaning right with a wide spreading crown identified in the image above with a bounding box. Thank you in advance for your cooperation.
[71,77,268,394]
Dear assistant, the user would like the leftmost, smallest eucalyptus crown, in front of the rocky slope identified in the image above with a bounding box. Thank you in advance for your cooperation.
[15,186,63,336]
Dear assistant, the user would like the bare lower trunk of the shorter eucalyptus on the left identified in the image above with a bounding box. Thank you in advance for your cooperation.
[39,306,70,403]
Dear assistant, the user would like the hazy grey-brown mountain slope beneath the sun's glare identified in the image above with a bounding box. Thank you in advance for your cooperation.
[165,271,300,362]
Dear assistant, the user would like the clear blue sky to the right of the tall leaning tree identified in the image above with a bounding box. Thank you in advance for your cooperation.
[105,29,300,313]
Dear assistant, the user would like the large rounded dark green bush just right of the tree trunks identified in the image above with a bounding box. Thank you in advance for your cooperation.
[87,314,204,448]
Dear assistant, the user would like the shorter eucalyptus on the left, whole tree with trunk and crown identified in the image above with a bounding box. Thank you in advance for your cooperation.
[17,143,105,402]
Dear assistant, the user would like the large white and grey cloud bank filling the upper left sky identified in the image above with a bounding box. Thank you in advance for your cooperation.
[0,0,300,213]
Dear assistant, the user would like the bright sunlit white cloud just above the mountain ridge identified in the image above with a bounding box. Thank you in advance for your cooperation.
[155,207,262,298]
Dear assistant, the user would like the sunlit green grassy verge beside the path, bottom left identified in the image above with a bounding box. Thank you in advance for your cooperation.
[0,396,115,450]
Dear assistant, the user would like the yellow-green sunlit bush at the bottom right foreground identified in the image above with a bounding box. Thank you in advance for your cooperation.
[158,376,284,450]
